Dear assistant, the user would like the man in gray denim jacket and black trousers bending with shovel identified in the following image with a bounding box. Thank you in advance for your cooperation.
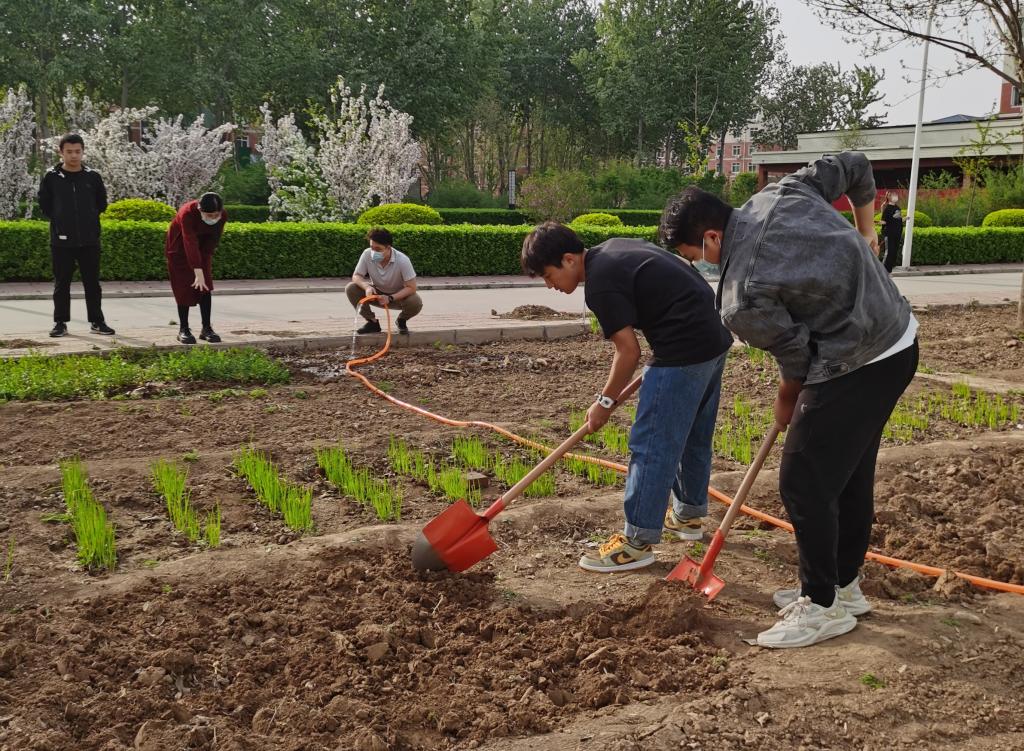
[660,152,918,648]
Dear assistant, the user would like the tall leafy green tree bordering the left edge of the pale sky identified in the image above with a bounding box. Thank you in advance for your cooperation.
[578,0,778,164]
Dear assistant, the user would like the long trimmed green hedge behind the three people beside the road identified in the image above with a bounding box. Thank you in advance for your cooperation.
[0,221,655,282]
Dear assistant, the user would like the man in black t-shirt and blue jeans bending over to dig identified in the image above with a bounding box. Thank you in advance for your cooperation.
[521,221,732,573]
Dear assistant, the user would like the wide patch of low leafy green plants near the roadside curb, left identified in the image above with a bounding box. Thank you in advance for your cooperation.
[0,347,290,401]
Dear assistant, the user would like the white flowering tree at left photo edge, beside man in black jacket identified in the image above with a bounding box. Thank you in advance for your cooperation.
[0,86,36,219]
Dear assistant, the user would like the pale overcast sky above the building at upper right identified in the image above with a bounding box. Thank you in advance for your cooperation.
[769,0,1001,125]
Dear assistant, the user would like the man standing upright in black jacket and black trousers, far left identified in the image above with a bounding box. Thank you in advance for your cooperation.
[39,133,114,336]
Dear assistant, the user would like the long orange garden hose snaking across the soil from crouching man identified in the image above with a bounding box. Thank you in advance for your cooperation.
[345,297,1024,594]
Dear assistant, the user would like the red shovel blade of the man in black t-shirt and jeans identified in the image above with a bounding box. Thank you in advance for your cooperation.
[413,500,498,572]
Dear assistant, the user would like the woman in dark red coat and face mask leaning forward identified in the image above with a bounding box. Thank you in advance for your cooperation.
[164,193,227,344]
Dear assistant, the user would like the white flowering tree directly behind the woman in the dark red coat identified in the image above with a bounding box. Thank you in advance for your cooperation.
[142,115,237,207]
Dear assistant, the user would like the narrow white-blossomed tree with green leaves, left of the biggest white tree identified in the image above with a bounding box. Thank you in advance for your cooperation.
[256,102,337,221]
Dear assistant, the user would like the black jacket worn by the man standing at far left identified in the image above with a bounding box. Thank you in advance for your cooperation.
[39,164,106,248]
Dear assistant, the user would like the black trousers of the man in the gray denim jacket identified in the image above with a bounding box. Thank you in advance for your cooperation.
[779,339,918,607]
